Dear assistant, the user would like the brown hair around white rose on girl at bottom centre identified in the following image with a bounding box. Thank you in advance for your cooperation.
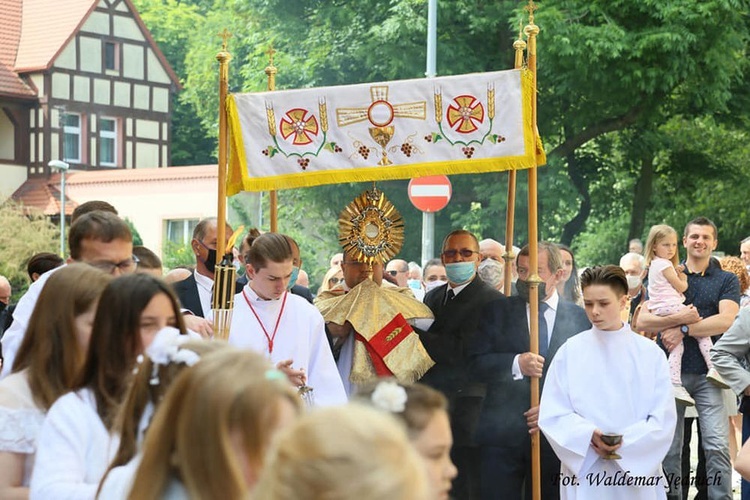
[357,379,448,439]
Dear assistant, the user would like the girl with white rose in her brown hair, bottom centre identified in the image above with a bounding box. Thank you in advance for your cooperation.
[357,380,458,500]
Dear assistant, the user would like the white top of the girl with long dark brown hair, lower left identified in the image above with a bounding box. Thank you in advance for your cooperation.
[30,389,120,500]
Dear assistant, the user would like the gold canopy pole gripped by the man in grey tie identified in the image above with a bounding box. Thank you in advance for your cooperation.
[524,0,542,500]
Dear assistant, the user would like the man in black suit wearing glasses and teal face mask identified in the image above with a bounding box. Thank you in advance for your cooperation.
[418,230,505,500]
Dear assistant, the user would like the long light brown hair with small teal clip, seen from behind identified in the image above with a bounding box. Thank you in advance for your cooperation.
[128,349,302,500]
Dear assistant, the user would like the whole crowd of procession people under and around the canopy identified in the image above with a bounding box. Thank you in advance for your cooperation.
[0,202,750,500]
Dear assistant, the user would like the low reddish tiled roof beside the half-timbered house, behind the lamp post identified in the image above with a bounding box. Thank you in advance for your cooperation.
[11,165,219,215]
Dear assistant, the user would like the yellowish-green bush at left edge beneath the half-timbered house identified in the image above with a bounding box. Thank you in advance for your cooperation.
[0,201,60,301]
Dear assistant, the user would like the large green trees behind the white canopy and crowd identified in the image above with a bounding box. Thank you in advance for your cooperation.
[132,0,750,279]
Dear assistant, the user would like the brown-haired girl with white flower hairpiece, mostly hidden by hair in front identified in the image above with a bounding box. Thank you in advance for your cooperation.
[97,327,231,500]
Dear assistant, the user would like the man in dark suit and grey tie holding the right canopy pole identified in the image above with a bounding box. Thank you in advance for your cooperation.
[471,242,591,500]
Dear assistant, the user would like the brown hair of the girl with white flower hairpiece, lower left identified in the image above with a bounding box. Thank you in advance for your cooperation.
[99,340,231,486]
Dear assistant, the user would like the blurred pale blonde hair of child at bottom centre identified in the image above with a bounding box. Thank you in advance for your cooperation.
[253,404,428,500]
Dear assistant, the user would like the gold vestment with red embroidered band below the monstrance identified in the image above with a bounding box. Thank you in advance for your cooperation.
[316,279,435,384]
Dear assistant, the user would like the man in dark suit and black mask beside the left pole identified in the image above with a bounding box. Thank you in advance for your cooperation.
[172,217,232,335]
